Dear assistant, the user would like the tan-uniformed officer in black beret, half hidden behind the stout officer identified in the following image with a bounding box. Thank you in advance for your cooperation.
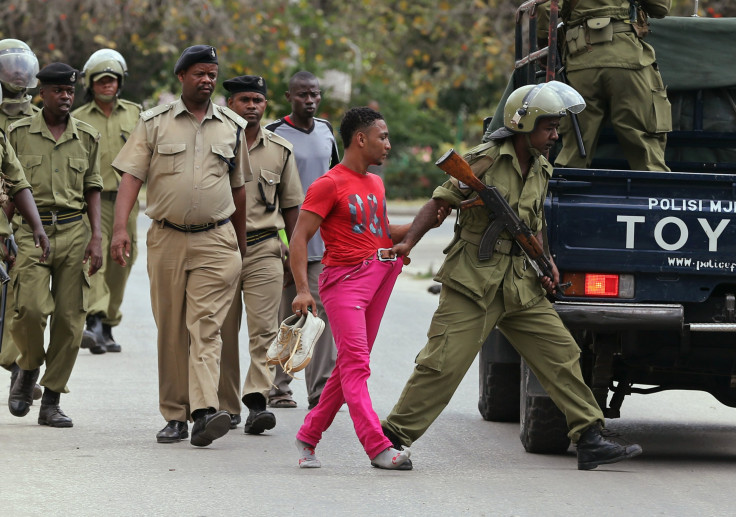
[220,75,304,434]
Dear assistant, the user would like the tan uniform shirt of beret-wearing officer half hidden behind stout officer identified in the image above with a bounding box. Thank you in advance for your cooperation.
[246,128,304,232]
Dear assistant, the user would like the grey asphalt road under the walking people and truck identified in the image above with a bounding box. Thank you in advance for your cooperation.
[0,211,736,517]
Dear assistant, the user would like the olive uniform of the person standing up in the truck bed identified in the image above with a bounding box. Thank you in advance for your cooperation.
[552,0,672,171]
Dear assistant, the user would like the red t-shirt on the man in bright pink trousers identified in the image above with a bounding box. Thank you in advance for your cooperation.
[302,164,393,266]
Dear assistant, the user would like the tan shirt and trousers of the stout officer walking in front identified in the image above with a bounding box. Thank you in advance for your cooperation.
[113,99,252,422]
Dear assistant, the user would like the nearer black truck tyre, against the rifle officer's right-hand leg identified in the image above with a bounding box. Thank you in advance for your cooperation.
[520,361,570,454]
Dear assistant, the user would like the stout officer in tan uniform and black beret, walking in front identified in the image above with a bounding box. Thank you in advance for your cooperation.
[111,45,252,446]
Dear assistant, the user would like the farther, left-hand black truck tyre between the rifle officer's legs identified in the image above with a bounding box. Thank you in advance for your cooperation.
[478,361,520,422]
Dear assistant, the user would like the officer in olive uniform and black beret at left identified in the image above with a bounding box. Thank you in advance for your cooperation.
[8,63,102,427]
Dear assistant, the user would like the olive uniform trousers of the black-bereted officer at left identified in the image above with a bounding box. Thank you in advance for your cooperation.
[11,220,90,393]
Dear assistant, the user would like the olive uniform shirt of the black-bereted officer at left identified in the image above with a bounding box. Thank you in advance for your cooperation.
[8,111,102,212]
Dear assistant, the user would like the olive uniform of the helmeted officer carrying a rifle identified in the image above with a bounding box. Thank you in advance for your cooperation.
[384,139,603,445]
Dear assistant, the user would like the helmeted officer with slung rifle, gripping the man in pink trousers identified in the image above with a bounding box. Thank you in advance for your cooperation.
[383,81,641,470]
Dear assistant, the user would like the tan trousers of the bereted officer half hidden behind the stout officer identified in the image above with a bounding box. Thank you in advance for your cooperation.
[218,238,284,415]
